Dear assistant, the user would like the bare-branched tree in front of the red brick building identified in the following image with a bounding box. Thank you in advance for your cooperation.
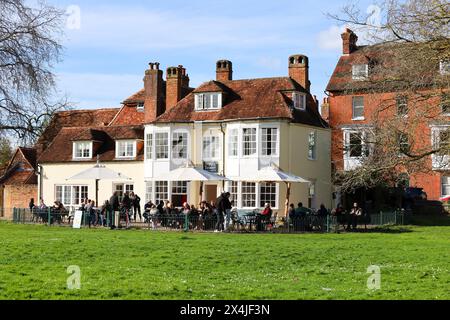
[329,0,450,192]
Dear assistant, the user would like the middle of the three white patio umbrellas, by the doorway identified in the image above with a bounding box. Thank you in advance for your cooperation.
[155,161,228,199]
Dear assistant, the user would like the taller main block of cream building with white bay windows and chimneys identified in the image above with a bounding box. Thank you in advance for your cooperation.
[143,55,331,211]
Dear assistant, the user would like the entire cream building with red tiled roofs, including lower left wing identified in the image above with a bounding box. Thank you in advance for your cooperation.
[38,55,331,215]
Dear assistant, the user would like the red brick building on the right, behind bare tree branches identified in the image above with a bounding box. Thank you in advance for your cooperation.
[322,29,450,210]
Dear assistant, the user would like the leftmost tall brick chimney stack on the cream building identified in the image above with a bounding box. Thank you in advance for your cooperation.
[144,62,164,123]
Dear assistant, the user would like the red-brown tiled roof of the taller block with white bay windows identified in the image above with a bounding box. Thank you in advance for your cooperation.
[155,77,327,127]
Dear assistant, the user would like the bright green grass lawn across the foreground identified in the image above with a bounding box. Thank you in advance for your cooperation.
[0,222,450,299]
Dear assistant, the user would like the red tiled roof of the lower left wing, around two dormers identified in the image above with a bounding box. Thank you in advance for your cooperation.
[39,126,144,163]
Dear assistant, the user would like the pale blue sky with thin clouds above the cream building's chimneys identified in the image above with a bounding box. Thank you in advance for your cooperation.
[51,0,372,109]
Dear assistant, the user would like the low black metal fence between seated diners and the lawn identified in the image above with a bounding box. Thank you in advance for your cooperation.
[8,208,405,233]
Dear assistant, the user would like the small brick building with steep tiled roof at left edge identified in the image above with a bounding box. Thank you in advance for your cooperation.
[0,147,37,219]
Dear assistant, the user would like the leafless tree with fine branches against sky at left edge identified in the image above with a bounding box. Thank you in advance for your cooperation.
[0,0,66,143]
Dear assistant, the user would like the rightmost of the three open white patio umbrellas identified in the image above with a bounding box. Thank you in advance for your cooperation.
[233,163,310,217]
